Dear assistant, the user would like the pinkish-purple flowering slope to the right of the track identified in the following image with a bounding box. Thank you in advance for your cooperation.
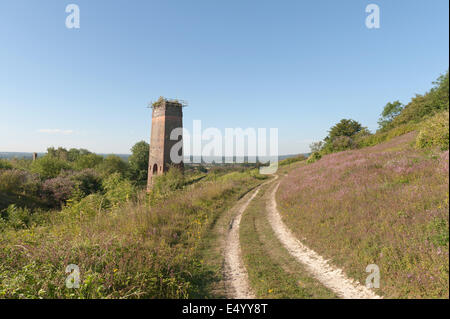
[277,132,449,298]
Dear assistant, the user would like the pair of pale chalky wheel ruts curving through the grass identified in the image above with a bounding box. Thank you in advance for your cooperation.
[224,176,381,299]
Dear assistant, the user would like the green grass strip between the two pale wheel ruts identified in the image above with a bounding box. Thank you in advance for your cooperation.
[240,183,336,299]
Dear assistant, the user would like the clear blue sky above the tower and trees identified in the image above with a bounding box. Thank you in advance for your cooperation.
[0,0,449,154]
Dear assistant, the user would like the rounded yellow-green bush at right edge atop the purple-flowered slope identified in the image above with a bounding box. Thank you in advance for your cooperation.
[416,111,449,151]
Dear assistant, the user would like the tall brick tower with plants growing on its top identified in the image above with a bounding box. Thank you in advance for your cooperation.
[147,97,185,189]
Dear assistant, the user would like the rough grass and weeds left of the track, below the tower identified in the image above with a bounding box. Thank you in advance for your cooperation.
[0,170,263,298]
